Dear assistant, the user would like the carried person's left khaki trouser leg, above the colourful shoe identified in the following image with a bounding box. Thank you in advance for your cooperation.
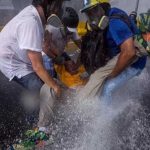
[38,82,76,127]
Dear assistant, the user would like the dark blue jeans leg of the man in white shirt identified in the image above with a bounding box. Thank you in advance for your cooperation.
[13,73,43,126]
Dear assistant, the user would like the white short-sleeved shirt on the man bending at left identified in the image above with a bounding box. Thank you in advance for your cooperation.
[0,5,44,80]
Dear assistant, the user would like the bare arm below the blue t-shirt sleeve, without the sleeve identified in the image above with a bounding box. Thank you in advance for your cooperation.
[110,38,136,78]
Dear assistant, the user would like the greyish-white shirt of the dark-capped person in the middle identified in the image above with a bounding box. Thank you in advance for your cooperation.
[46,25,80,54]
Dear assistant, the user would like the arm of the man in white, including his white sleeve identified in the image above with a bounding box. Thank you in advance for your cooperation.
[16,19,60,95]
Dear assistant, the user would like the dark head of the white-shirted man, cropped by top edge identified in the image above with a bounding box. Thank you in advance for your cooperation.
[32,0,63,19]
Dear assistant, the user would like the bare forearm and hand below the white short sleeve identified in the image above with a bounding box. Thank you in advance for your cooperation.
[28,50,60,95]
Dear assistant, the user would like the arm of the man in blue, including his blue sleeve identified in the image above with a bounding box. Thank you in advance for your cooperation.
[109,19,136,78]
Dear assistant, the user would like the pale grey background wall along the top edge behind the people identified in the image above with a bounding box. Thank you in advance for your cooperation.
[0,0,150,24]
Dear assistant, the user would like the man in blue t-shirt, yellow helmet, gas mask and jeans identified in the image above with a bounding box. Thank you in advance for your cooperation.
[81,0,146,103]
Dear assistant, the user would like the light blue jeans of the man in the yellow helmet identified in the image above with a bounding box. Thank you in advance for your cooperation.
[100,67,142,104]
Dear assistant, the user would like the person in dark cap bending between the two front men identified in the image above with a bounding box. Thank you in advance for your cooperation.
[43,7,81,74]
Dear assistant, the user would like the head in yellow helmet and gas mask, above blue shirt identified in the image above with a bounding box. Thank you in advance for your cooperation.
[81,0,110,29]
